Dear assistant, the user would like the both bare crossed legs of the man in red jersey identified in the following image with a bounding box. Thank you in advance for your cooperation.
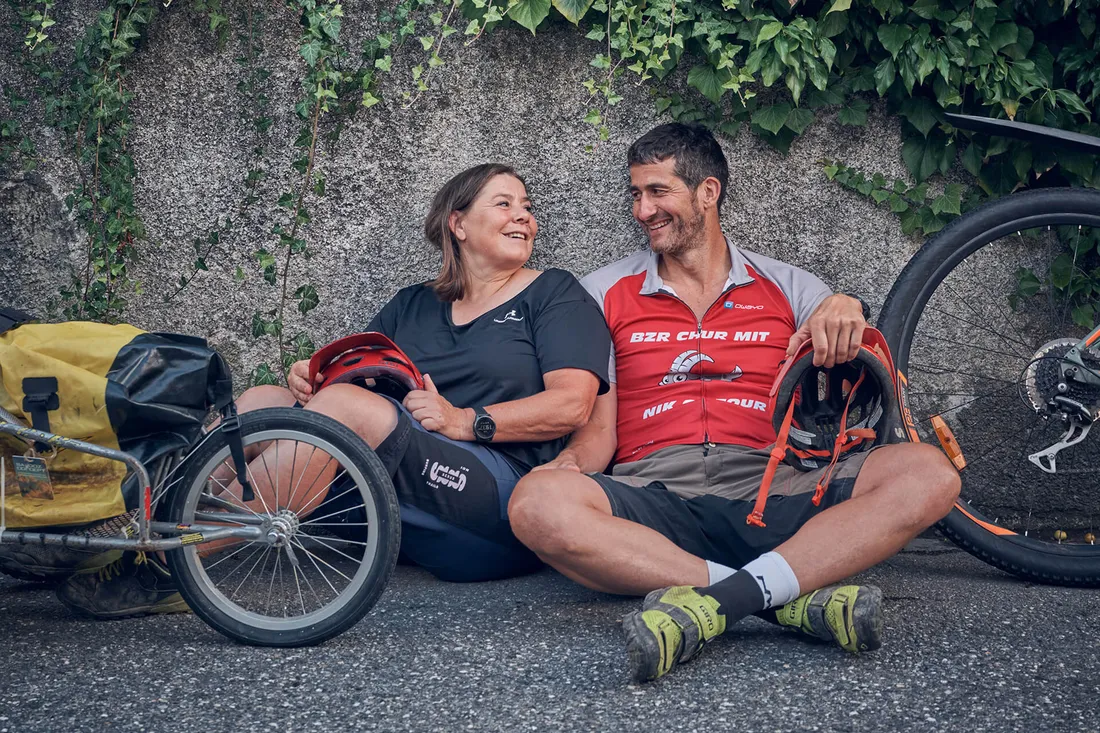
[508,445,959,595]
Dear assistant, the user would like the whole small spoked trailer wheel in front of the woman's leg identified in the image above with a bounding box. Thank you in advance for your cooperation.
[166,407,400,646]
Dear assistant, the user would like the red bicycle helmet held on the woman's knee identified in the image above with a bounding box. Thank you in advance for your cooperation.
[309,331,424,400]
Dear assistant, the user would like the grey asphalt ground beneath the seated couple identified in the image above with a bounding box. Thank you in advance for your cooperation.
[0,539,1100,733]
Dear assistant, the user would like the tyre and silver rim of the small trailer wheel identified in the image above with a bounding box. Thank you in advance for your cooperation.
[160,407,400,647]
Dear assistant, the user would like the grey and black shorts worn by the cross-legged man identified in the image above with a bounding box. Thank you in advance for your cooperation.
[591,445,870,568]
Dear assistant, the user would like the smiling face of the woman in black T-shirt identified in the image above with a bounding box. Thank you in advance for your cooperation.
[451,174,539,270]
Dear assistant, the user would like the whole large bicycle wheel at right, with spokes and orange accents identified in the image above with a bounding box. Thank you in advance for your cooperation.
[879,188,1100,586]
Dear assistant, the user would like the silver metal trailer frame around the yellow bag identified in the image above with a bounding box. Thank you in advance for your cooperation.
[0,411,266,553]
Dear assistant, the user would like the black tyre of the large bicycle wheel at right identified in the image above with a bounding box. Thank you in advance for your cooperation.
[878,188,1100,587]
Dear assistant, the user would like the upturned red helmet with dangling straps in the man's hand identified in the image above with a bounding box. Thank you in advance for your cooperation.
[747,328,903,527]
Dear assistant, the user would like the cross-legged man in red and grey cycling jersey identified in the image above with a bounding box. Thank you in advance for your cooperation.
[508,124,959,681]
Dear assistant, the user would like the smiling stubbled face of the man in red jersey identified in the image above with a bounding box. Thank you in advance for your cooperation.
[630,157,705,256]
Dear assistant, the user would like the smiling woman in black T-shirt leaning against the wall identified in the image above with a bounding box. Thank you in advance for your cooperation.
[238,164,611,581]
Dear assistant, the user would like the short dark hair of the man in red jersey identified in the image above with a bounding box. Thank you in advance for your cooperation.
[626,122,729,211]
